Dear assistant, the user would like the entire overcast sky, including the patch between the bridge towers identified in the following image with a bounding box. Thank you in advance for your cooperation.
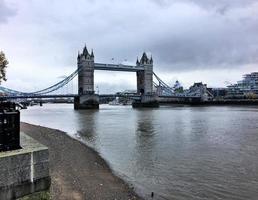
[0,0,258,93]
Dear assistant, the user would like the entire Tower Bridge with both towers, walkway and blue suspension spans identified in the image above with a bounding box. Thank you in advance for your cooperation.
[0,46,208,109]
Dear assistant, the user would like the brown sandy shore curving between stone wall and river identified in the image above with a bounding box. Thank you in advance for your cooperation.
[21,123,142,200]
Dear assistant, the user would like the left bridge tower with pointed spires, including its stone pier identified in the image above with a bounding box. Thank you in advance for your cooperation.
[74,45,99,109]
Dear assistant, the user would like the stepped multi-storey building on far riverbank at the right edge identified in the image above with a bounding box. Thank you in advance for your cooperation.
[227,72,258,98]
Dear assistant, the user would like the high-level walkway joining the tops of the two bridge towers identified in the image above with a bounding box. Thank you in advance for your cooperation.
[94,63,144,72]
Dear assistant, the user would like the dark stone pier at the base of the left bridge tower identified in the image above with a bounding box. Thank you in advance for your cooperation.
[74,94,99,110]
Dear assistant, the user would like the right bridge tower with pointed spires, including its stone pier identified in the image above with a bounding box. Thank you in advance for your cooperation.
[132,52,159,107]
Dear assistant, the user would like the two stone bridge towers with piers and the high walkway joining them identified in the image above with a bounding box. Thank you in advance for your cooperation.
[74,46,158,109]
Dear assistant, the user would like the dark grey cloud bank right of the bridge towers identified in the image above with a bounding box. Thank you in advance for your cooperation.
[149,18,258,70]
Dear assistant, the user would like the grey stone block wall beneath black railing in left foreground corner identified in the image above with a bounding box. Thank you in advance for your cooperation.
[0,133,50,200]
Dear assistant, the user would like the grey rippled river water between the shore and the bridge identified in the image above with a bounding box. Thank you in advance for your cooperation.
[21,104,258,200]
